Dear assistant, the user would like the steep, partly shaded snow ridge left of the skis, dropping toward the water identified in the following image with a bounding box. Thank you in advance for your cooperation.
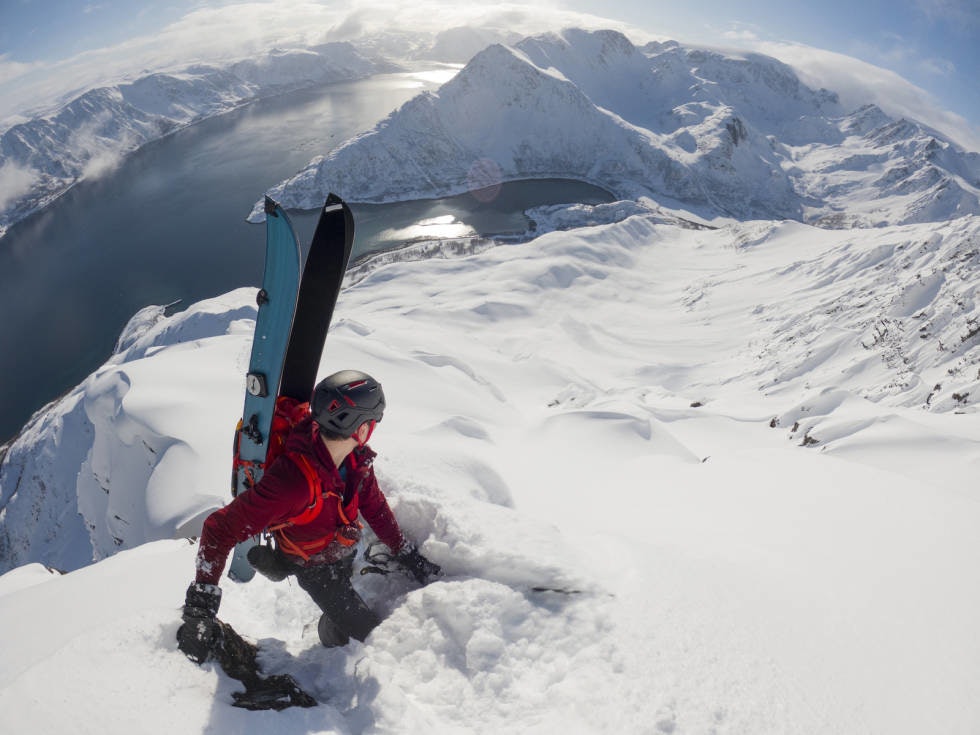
[0,289,255,569]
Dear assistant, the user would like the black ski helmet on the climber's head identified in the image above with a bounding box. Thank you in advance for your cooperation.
[310,370,385,437]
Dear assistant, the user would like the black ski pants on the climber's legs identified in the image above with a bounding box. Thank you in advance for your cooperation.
[295,554,381,646]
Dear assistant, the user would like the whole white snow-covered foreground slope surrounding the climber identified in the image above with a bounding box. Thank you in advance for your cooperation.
[0,205,980,735]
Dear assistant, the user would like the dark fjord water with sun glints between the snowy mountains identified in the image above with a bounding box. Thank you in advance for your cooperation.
[0,71,609,442]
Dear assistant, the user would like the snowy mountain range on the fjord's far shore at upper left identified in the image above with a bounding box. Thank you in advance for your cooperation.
[0,44,382,237]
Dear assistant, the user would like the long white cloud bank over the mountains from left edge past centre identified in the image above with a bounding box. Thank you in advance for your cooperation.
[0,0,652,125]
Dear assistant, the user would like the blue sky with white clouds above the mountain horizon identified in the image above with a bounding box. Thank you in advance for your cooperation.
[0,0,980,147]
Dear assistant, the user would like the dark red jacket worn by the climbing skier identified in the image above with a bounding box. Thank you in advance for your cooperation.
[197,418,405,584]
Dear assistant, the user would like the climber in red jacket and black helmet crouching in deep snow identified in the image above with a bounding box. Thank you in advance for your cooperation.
[177,370,440,663]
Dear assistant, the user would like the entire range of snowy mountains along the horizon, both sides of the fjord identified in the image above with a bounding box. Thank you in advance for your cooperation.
[0,29,980,236]
